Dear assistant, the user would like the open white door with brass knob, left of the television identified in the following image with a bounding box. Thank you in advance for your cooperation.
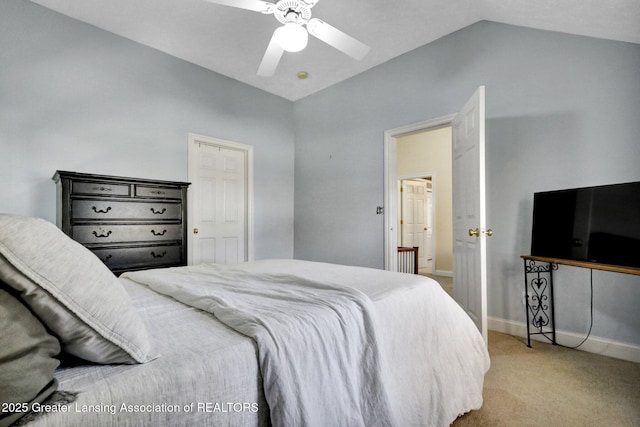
[452,86,492,342]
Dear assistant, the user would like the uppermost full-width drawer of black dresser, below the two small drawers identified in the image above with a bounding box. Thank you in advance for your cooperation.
[71,200,182,220]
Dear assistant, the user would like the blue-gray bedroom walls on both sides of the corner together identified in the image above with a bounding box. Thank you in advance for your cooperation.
[0,0,640,345]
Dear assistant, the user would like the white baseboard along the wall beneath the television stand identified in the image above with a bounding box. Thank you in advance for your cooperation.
[487,317,640,363]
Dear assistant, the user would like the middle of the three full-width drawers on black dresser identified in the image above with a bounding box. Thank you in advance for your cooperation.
[71,224,182,244]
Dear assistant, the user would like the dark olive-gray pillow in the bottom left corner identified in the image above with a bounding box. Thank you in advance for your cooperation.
[0,287,60,426]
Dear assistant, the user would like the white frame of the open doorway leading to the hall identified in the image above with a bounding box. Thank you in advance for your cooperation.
[384,113,456,271]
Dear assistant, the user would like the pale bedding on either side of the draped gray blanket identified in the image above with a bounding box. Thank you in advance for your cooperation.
[22,260,490,427]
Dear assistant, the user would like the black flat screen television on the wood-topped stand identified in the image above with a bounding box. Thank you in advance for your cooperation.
[531,182,640,267]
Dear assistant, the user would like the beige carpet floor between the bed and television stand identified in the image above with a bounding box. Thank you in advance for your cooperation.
[453,331,640,427]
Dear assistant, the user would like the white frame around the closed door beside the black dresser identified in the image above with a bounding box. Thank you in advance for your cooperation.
[187,132,254,265]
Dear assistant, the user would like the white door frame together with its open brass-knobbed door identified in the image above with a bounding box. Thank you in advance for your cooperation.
[384,86,493,342]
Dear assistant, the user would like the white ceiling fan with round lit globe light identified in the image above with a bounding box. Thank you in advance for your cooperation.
[207,0,370,76]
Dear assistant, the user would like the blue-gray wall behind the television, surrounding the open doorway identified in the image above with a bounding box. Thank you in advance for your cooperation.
[294,22,640,345]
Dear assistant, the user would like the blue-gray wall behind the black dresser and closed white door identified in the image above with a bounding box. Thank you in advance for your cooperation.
[0,0,294,258]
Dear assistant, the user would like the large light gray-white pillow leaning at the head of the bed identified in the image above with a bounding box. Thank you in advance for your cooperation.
[0,214,154,363]
